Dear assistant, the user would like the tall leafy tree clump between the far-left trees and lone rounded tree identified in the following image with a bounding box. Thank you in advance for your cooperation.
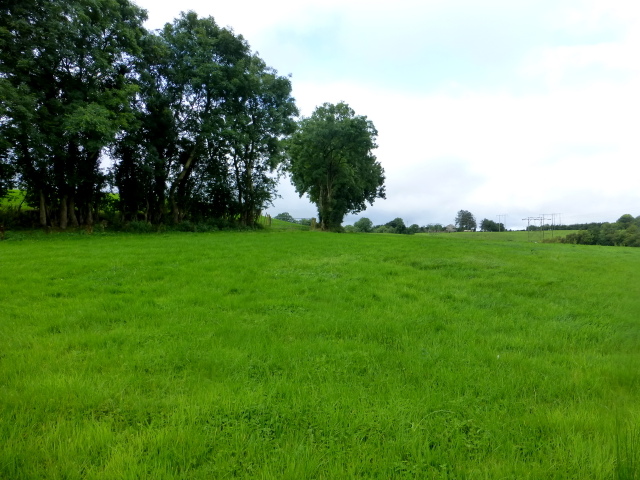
[131,12,297,225]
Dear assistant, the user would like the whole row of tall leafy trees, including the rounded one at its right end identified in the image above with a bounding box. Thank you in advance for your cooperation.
[0,0,384,229]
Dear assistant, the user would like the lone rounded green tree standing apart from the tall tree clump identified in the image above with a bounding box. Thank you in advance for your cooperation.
[289,102,385,230]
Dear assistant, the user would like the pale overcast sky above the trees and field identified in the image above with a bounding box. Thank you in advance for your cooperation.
[134,0,640,228]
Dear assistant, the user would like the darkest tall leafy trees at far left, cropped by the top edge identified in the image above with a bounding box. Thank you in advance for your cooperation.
[0,0,145,228]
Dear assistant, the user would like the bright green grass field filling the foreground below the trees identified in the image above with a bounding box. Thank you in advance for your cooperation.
[0,229,640,480]
